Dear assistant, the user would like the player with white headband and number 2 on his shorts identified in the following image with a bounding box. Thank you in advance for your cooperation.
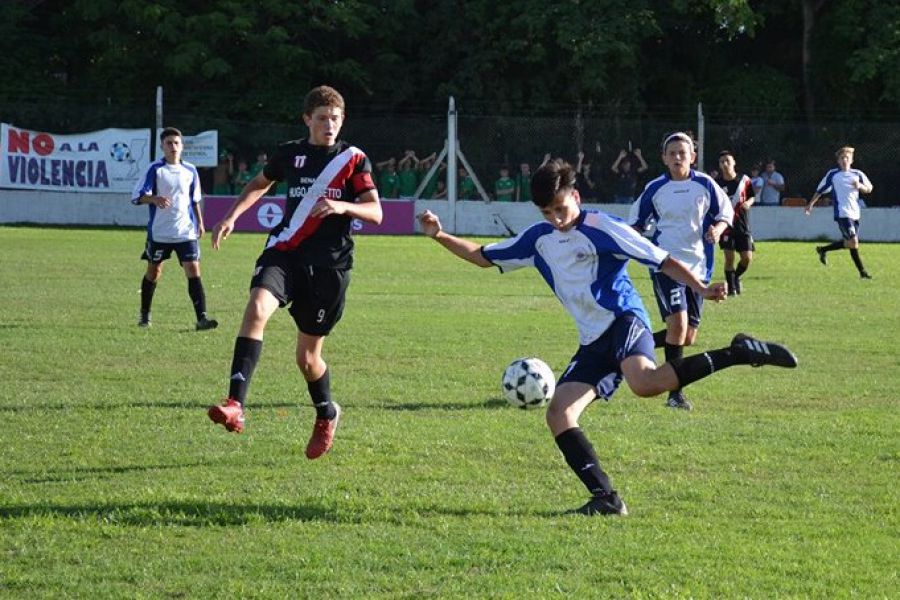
[629,132,734,410]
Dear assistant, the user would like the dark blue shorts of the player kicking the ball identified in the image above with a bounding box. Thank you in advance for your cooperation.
[557,313,656,400]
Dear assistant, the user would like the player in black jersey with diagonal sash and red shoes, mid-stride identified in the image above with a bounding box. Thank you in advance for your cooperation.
[208,86,382,459]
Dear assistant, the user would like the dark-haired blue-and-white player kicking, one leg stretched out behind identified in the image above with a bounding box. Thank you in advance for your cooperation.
[418,160,797,515]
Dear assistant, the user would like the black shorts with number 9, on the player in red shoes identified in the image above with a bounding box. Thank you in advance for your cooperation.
[250,250,350,336]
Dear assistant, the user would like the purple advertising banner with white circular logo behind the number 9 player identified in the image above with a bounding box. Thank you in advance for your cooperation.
[203,196,416,235]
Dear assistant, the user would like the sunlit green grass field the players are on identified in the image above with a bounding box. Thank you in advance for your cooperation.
[0,227,900,598]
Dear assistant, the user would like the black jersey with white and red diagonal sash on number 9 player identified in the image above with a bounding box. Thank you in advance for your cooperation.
[263,140,375,269]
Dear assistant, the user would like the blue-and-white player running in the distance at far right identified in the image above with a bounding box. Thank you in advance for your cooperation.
[806,146,873,279]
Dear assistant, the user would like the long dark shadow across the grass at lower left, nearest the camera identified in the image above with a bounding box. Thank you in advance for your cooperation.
[0,501,344,527]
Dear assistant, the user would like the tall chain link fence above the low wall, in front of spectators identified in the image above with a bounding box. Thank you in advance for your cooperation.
[7,100,900,206]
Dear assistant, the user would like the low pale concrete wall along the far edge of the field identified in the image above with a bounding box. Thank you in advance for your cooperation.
[0,190,900,242]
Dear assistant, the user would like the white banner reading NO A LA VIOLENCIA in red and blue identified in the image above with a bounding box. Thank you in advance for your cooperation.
[0,123,150,194]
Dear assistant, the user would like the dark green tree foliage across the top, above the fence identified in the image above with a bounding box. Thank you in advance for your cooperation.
[0,0,900,126]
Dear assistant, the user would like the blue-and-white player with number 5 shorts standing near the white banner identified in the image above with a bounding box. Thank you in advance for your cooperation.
[131,127,219,331]
